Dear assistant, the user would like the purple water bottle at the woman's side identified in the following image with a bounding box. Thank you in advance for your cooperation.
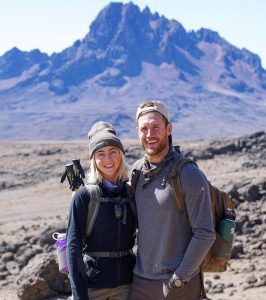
[52,232,68,273]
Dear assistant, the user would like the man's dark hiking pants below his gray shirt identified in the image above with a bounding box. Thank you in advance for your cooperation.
[129,275,201,300]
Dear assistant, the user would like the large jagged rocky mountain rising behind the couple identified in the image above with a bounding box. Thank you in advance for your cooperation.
[0,2,266,140]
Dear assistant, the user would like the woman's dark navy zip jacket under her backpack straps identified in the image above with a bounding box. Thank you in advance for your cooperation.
[67,183,136,300]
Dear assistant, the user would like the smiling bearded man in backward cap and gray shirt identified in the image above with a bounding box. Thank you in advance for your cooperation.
[130,101,215,300]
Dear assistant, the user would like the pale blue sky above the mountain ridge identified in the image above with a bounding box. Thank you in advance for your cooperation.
[0,0,266,68]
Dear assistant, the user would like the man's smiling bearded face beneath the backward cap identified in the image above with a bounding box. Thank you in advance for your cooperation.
[137,112,172,162]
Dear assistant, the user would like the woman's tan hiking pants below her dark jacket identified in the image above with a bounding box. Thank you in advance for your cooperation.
[88,284,130,300]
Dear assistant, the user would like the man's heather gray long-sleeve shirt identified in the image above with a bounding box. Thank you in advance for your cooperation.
[133,155,215,280]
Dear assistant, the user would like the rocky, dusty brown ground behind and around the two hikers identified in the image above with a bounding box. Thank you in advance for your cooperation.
[0,132,266,300]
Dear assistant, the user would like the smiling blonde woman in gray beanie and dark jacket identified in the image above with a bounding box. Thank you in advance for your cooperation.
[67,122,136,300]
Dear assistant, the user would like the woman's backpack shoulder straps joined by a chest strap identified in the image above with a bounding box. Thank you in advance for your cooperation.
[85,183,137,238]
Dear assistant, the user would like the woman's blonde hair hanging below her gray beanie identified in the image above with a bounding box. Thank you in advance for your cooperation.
[88,149,128,183]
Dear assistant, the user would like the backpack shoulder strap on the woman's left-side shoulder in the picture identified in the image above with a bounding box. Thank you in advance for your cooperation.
[85,184,101,237]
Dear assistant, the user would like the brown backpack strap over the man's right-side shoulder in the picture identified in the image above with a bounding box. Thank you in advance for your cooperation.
[168,156,197,212]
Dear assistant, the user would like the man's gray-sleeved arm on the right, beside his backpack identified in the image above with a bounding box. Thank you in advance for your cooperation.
[175,163,215,280]
